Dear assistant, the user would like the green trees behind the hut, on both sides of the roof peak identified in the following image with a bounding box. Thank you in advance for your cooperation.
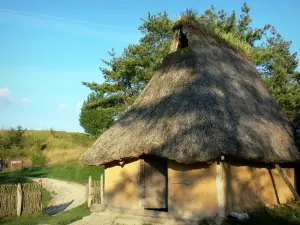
[80,3,300,134]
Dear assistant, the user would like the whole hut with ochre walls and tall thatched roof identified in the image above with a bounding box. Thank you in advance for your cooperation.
[81,17,300,217]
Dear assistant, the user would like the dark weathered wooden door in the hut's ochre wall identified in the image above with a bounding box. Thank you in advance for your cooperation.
[140,156,168,210]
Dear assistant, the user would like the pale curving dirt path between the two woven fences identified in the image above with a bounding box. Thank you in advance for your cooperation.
[29,177,86,212]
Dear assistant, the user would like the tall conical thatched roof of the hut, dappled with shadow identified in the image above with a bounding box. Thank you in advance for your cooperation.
[81,22,300,165]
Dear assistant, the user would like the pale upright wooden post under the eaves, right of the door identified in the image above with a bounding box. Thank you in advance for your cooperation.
[216,162,225,217]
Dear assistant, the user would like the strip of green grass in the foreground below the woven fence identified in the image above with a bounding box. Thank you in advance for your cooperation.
[0,204,90,225]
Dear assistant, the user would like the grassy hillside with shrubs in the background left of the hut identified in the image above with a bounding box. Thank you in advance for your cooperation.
[0,127,95,166]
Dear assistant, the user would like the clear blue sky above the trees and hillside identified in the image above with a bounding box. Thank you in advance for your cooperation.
[0,0,300,132]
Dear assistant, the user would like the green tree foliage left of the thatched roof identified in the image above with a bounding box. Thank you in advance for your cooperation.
[79,12,173,135]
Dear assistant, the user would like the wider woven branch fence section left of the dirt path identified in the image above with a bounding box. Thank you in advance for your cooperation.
[0,182,42,217]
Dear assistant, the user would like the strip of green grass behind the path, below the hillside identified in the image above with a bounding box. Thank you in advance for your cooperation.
[0,163,104,184]
